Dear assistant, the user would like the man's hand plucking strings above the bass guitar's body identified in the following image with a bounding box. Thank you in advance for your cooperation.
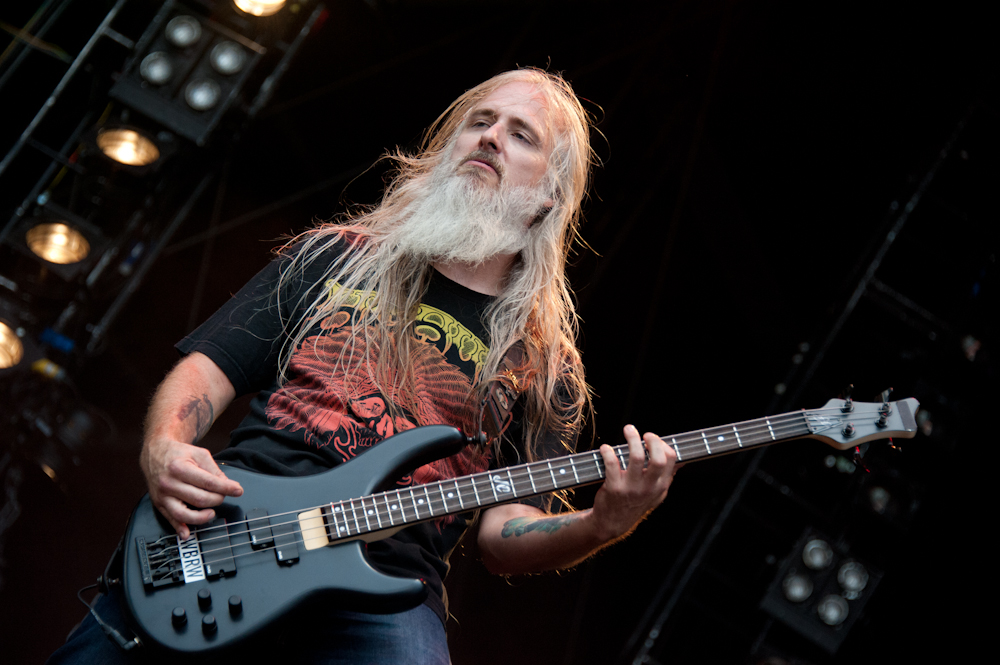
[141,439,243,540]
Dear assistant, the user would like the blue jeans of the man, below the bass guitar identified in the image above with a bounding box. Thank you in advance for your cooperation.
[48,596,451,665]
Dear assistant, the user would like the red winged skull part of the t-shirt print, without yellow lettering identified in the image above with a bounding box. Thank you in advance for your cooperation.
[266,319,487,521]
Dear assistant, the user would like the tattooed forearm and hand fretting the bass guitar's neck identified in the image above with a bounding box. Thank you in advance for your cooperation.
[478,425,677,575]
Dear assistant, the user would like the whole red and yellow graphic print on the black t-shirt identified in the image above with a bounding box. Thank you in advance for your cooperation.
[266,285,489,516]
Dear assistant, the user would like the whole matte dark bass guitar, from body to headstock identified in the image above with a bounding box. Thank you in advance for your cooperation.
[122,398,918,654]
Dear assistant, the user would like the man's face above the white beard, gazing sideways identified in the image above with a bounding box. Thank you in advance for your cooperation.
[451,83,552,201]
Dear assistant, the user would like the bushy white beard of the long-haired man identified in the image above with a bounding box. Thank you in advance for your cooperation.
[389,165,546,264]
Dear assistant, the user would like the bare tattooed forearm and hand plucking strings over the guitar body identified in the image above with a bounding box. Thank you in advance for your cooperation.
[140,352,243,539]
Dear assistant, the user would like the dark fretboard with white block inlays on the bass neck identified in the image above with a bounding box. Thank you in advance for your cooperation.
[323,411,825,540]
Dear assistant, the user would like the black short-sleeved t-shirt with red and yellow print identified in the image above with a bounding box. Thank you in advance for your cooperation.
[177,243,540,621]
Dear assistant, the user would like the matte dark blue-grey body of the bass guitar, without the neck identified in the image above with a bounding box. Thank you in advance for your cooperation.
[123,426,467,653]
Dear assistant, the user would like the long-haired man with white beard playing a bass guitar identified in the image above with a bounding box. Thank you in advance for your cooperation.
[45,69,675,665]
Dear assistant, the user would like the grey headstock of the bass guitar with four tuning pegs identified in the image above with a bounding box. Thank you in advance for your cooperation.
[804,397,920,450]
